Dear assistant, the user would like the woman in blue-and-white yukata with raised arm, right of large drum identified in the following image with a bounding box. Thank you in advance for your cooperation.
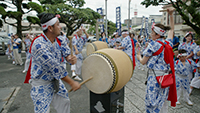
[136,8,174,113]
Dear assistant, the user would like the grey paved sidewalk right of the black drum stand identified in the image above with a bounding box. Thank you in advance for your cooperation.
[124,67,200,113]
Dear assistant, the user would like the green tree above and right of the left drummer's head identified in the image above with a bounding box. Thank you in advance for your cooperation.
[39,0,100,36]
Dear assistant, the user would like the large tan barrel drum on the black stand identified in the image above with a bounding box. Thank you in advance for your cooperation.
[82,48,133,94]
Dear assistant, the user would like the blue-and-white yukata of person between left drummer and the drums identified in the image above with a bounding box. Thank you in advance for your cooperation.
[71,35,88,75]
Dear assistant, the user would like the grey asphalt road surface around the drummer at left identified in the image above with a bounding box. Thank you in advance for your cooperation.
[0,53,89,113]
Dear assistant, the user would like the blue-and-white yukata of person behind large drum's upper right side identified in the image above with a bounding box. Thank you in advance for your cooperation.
[121,36,133,61]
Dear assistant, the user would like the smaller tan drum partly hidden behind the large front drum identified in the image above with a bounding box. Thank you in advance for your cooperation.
[87,41,108,56]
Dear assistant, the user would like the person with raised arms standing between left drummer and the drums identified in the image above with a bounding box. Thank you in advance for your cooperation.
[71,28,89,81]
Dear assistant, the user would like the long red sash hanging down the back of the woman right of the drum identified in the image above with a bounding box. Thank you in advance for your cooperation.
[152,41,177,107]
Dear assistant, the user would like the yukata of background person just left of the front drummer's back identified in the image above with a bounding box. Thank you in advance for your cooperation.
[24,38,31,71]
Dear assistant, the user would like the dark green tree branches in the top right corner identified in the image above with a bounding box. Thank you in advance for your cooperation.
[141,0,200,35]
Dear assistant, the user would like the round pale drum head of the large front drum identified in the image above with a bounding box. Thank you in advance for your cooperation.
[82,54,114,94]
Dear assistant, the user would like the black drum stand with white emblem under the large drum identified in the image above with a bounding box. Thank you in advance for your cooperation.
[90,87,124,113]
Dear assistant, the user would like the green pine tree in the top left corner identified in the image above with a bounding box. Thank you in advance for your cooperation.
[0,0,43,37]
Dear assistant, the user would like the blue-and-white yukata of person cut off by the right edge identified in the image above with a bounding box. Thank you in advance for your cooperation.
[190,45,200,89]
